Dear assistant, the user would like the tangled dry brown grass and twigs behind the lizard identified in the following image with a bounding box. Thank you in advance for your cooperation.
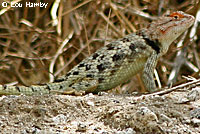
[0,0,200,92]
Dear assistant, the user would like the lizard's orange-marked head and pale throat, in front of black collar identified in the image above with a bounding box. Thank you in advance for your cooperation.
[147,11,195,54]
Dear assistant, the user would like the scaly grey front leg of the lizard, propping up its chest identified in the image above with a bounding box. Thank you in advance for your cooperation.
[142,51,160,92]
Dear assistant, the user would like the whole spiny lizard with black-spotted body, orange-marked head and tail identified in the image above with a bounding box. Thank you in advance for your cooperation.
[0,11,195,95]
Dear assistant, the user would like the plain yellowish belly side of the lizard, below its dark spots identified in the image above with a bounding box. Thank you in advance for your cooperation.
[96,57,147,92]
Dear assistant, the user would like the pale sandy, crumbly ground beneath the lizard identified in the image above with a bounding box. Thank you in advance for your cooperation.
[0,87,200,134]
